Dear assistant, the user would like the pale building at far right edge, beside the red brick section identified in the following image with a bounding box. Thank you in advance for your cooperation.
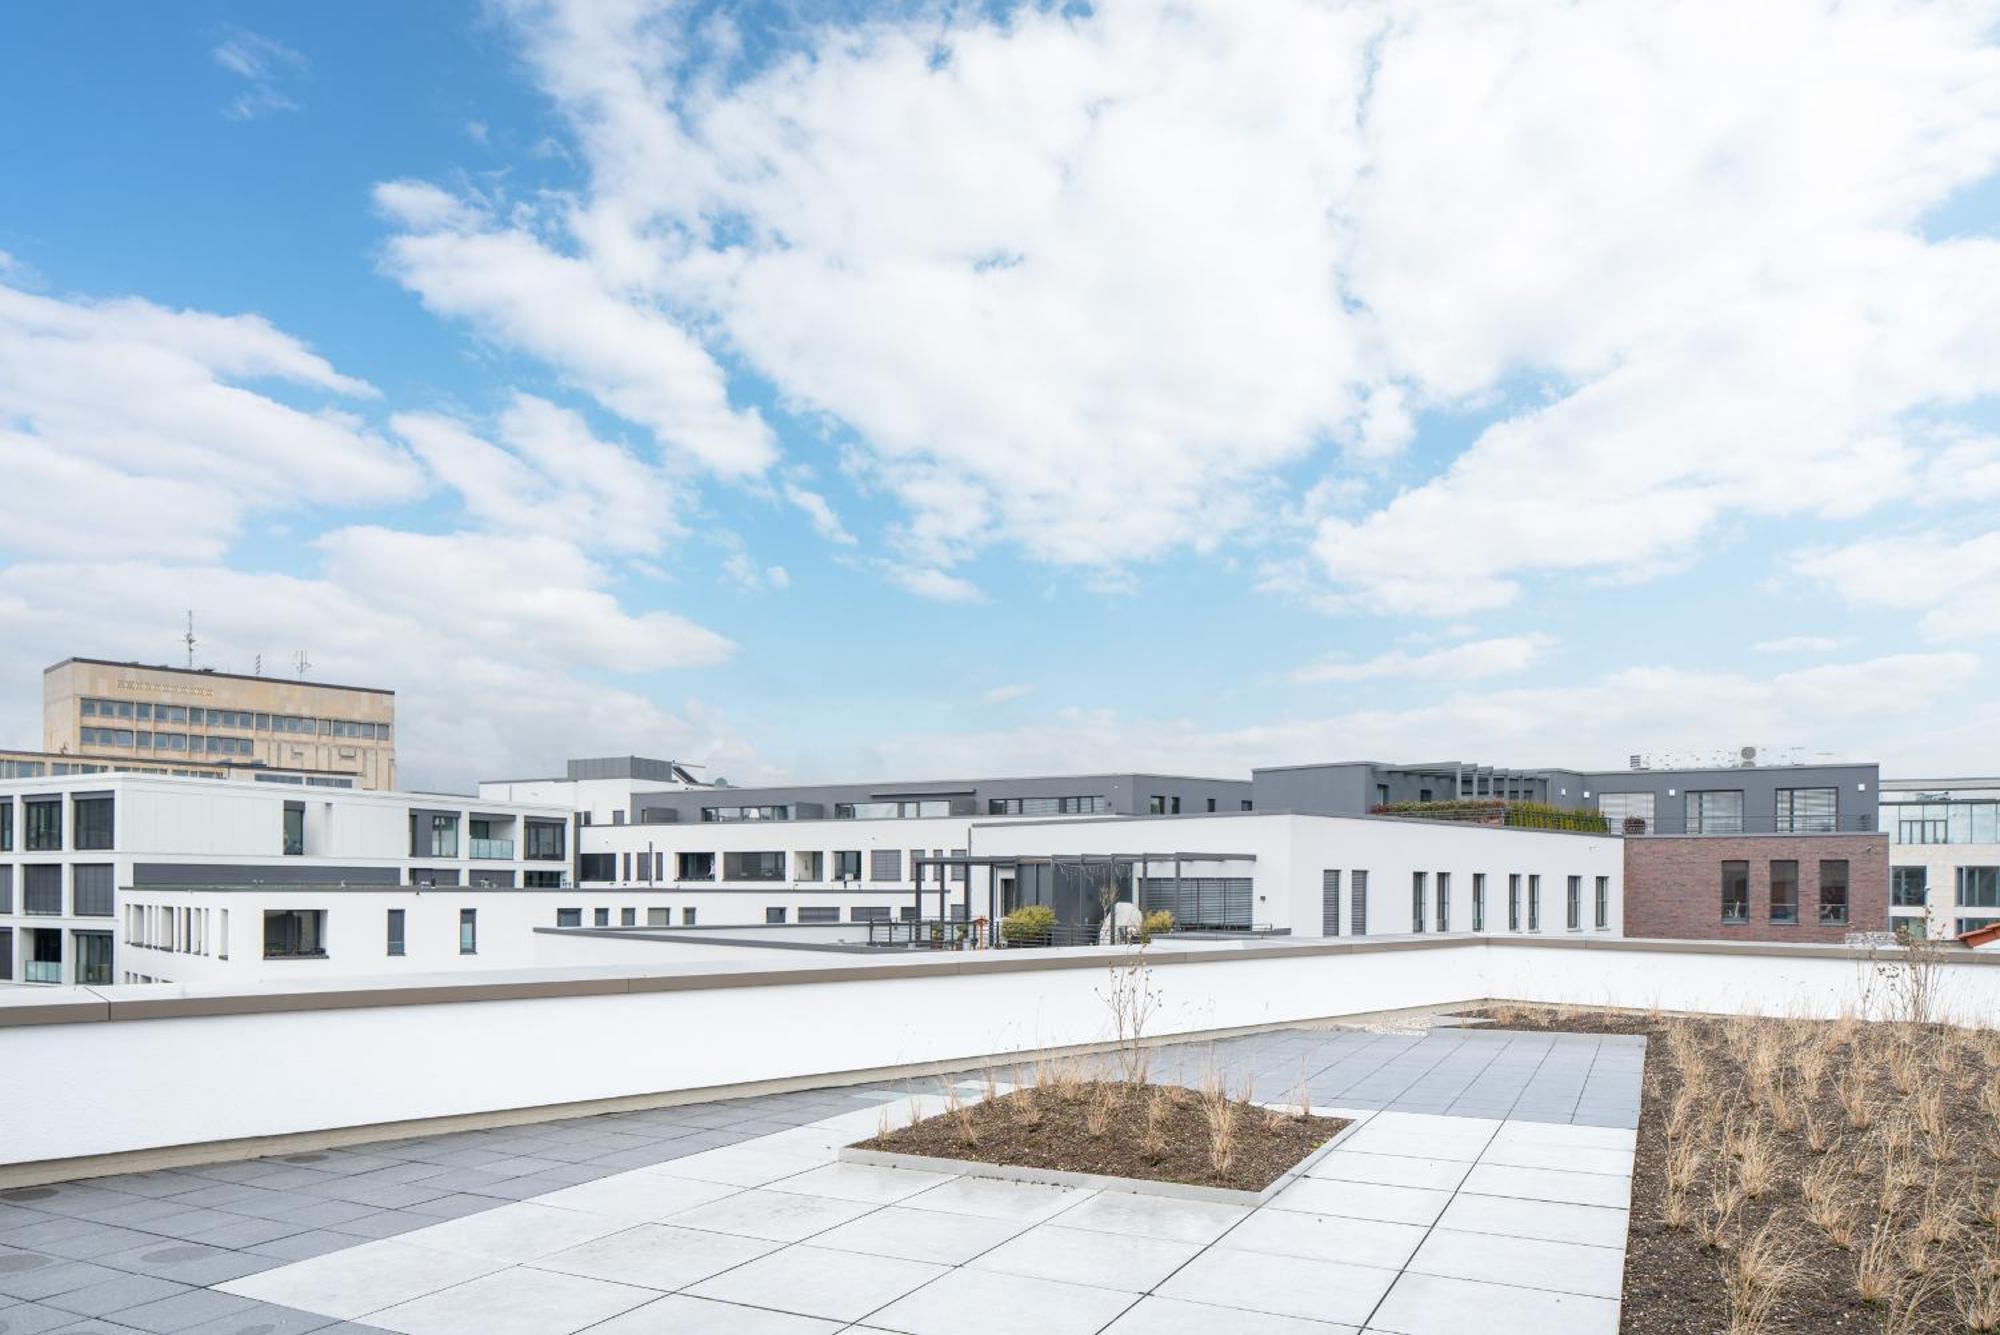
[1882,777,2000,937]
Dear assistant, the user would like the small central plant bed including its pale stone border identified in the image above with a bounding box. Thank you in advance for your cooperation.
[840,1079,1356,1205]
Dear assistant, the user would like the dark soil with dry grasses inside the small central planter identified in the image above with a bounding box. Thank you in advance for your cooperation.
[856,1081,1348,1191]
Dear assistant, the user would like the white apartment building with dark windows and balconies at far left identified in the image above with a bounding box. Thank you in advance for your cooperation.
[0,773,570,985]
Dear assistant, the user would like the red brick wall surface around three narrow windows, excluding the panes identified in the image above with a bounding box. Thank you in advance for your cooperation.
[1624,833,1888,943]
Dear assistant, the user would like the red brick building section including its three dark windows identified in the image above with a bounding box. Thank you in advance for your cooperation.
[1624,831,1888,943]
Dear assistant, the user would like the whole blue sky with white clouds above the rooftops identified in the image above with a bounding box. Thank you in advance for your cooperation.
[0,0,2000,787]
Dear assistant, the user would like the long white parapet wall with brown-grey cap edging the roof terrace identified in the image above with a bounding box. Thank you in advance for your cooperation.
[0,935,2000,1185]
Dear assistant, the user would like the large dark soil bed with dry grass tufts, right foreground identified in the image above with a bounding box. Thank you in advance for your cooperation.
[1466,1003,2000,1335]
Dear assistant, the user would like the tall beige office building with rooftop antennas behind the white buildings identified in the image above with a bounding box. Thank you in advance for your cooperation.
[42,658,396,789]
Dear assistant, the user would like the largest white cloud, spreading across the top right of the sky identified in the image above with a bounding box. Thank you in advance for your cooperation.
[368,0,2000,616]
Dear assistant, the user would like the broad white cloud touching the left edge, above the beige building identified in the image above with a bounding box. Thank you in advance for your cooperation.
[0,286,422,560]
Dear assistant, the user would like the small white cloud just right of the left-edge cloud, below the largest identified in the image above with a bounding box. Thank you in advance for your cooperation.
[390,394,682,556]
